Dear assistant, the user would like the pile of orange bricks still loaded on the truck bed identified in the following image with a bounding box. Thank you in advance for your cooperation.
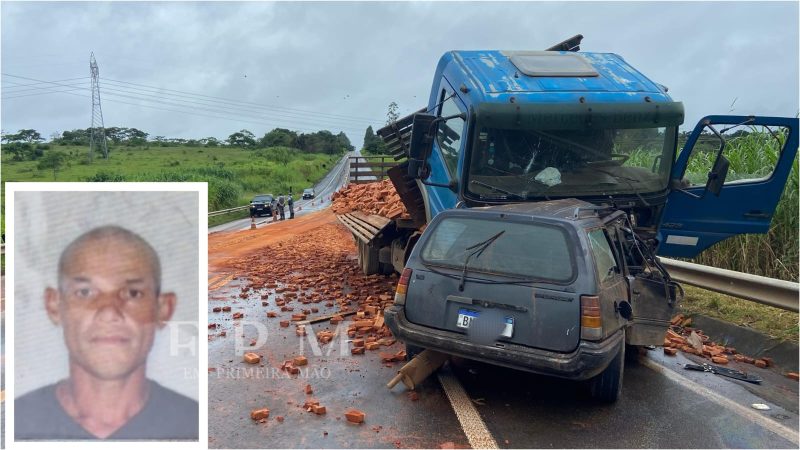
[331,179,411,219]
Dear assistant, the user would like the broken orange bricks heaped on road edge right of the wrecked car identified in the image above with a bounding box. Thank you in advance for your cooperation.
[664,314,798,380]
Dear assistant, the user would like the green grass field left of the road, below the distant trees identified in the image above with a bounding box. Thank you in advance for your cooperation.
[2,146,341,211]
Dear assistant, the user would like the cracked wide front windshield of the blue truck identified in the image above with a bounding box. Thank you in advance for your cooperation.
[465,123,677,200]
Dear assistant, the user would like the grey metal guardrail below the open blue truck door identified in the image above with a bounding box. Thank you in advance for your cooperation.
[659,258,800,312]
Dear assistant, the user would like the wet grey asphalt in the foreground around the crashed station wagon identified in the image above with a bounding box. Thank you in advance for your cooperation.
[209,206,798,448]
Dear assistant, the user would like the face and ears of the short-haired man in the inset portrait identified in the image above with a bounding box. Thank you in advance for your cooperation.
[46,238,175,380]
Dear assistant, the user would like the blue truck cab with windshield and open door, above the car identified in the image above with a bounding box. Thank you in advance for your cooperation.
[379,40,798,257]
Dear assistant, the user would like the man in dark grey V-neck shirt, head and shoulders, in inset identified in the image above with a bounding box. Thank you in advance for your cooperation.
[14,225,199,440]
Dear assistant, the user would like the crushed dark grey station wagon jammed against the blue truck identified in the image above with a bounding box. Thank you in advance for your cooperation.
[385,199,679,402]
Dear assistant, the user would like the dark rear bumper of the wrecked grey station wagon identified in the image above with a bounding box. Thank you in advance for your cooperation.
[384,305,624,380]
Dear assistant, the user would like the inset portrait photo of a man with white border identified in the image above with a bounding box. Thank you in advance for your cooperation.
[5,183,207,444]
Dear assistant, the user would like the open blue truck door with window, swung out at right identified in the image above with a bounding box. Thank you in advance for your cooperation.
[657,116,798,258]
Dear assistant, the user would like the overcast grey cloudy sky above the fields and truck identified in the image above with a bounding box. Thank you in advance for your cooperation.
[0,1,800,147]
